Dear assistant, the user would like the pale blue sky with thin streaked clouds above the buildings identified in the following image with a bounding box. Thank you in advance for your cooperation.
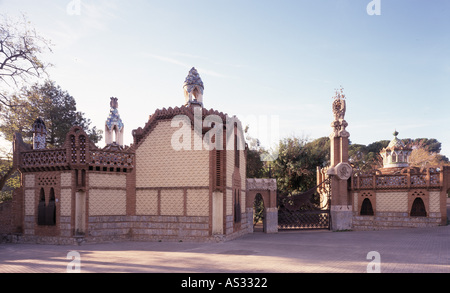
[0,0,450,157]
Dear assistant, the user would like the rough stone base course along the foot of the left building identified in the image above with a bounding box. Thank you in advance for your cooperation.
[0,213,249,245]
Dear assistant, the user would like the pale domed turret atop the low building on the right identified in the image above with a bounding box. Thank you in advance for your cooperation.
[380,131,412,168]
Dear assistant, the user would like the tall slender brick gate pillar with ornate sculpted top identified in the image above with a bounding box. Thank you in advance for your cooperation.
[327,89,353,230]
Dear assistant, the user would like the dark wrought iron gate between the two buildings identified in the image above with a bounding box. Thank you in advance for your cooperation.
[277,178,331,230]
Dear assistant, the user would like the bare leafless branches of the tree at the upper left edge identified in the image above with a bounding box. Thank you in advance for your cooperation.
[0,16,52,109]
